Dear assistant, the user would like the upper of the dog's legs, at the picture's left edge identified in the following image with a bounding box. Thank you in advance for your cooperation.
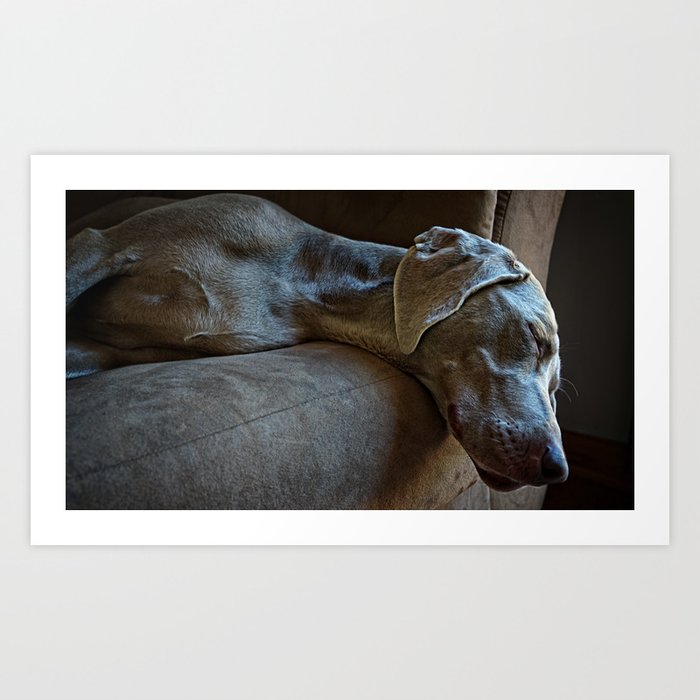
[66,228,140,309]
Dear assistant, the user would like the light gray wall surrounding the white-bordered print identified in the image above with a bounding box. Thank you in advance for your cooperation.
[0,0,700,700]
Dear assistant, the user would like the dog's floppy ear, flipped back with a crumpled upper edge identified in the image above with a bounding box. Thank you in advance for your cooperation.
[394,226,529,355]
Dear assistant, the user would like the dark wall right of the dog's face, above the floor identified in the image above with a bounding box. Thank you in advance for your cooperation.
[547,191,634,442]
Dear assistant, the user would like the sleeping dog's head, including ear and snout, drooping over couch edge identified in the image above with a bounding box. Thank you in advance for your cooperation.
[394,227,568,491]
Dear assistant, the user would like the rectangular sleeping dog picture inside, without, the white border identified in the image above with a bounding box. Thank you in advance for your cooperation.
[66,190,634,510]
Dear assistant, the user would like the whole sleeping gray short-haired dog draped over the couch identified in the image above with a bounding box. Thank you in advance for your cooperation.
[66,194,568,491]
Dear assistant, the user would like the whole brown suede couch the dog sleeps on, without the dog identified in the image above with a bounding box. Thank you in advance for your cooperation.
[66,190,564,509]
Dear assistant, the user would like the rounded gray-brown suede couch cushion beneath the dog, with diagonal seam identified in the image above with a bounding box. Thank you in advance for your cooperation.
[67,343,477,509]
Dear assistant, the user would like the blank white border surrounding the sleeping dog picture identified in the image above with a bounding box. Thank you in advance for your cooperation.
[31,155,669,545]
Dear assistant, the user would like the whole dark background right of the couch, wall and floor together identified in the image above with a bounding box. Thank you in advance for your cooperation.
[545,190,634,509]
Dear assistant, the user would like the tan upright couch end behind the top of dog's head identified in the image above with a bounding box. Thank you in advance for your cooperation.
[493,190,565,289]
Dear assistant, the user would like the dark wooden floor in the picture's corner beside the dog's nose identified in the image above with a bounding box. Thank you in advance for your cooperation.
[543,431,634,510]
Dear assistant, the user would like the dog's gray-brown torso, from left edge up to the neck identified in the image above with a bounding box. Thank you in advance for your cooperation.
[68,194,328,364]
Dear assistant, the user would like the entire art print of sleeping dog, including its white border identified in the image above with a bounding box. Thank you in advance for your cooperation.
[32,156,668,544]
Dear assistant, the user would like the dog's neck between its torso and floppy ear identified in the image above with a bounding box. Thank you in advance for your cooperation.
[294,232,413,371]
